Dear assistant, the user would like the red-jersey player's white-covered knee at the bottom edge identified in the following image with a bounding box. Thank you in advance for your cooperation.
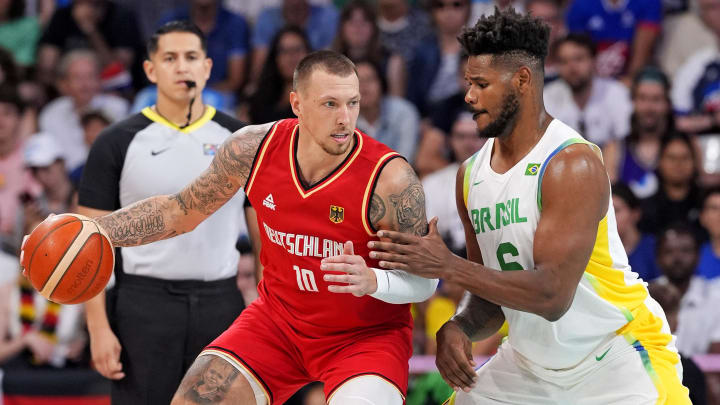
[329,375,403,405]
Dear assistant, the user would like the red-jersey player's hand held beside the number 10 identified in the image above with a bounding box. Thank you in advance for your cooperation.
[320,241,377,297]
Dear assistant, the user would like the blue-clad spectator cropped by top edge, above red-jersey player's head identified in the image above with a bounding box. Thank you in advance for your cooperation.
[252,0,339,84]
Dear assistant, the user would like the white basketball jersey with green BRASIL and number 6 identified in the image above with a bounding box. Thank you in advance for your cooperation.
[463,119,647,369]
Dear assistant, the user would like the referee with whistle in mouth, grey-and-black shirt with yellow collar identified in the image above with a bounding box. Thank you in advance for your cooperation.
[78,21,244,405]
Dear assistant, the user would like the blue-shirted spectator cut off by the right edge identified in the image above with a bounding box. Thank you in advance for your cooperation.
[697,187,720,278]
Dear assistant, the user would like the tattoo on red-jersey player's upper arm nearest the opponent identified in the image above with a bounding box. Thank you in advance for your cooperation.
[388,167,428,236]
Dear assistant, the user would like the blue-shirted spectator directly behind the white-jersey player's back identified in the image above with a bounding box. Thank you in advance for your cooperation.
[612,183,662,281]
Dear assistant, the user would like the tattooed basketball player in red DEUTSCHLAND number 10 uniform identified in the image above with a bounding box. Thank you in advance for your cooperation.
[28,51,437,405]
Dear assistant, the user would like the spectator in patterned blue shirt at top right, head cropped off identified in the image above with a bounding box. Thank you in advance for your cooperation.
[567,0,662,85]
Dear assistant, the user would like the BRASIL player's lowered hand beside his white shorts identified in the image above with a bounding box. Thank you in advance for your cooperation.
[435,321,477,392]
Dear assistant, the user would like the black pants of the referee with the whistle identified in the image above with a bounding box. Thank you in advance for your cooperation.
[108,274,245,405]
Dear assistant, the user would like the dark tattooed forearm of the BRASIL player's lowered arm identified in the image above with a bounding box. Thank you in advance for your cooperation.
[452,292,505,340]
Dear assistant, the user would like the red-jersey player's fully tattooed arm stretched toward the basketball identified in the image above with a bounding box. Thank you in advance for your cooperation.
[97,124,272,246]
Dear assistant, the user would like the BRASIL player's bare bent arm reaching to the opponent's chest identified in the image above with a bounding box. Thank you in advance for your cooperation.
[371,144,610,321]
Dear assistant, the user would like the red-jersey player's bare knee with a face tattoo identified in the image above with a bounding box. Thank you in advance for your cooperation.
[171,354,267,405]
